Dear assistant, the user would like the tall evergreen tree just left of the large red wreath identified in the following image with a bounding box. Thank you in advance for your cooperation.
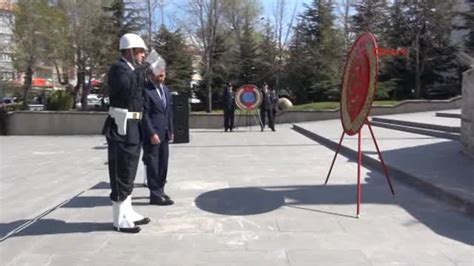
[286,0,344,103]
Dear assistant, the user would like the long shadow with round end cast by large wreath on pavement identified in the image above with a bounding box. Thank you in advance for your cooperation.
[195,172,474,245]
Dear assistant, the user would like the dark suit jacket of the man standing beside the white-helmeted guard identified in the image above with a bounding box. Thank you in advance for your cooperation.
[143,82,174,144]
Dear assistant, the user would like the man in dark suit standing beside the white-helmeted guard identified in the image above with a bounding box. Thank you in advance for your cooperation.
[143,71,174,205]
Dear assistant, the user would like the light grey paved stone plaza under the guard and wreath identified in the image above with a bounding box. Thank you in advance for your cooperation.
[0,115,474,266]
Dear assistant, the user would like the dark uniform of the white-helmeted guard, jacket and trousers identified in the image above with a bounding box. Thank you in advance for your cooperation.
[102,58,145,201]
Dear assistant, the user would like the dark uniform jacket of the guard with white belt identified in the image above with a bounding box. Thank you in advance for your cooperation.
[102,59,145,144]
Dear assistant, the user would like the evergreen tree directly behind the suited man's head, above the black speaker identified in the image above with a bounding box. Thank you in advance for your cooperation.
[153,26,193,93]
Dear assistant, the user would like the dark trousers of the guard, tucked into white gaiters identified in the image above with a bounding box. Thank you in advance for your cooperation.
[107,138,141,201]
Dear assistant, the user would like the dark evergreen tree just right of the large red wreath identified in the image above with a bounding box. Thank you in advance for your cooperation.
[381,0,460,98]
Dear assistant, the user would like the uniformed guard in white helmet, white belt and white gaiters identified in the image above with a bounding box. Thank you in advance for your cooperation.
[102,33,150,233]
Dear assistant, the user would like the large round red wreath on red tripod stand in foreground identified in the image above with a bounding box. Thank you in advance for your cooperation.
[324,32,408,217]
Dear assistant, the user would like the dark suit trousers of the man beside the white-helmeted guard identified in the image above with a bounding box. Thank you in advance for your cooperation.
[143,141,169,197]
